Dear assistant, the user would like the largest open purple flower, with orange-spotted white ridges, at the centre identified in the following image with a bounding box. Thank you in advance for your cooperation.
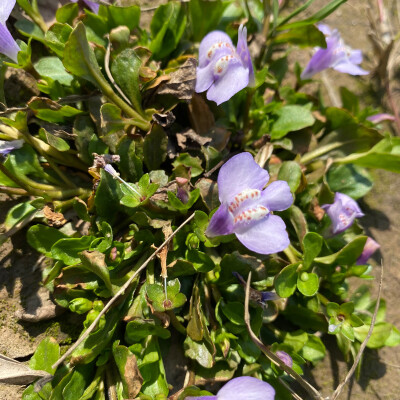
[206,153,293,254]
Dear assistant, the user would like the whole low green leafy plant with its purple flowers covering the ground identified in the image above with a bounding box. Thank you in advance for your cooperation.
[0,0,400,400]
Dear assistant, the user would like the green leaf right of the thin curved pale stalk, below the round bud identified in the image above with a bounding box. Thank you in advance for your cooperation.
[111,48,142,112]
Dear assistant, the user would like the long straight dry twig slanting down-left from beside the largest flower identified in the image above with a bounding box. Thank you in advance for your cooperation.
[51,213,194,370]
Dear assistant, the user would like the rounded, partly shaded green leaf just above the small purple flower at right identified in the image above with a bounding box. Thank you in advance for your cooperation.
[327,164,373,199]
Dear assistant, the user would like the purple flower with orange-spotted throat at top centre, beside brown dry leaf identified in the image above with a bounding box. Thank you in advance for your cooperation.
[196,25,254,105]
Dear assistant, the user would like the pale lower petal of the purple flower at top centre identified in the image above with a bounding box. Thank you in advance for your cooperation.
[207,58,249,105]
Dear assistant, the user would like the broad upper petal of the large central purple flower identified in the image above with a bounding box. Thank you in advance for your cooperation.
[218,153,269,204]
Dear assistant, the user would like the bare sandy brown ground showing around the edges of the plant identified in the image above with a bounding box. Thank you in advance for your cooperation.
[0,0,400,400]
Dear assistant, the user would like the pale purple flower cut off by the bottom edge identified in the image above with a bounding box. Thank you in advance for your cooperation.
[185,376,275,400]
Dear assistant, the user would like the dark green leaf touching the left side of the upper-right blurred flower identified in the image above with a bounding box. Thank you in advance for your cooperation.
[273,25,326,48]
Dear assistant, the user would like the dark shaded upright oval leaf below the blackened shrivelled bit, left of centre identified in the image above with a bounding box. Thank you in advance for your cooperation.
[143,124,167,170]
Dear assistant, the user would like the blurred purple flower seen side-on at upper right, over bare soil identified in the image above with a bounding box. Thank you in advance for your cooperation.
[301,24,369,79]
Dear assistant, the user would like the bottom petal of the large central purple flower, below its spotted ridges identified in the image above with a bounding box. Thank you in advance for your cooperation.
[235,215,290,254]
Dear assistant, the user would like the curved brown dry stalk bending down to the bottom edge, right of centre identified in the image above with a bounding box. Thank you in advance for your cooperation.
[244,272,324,400]
